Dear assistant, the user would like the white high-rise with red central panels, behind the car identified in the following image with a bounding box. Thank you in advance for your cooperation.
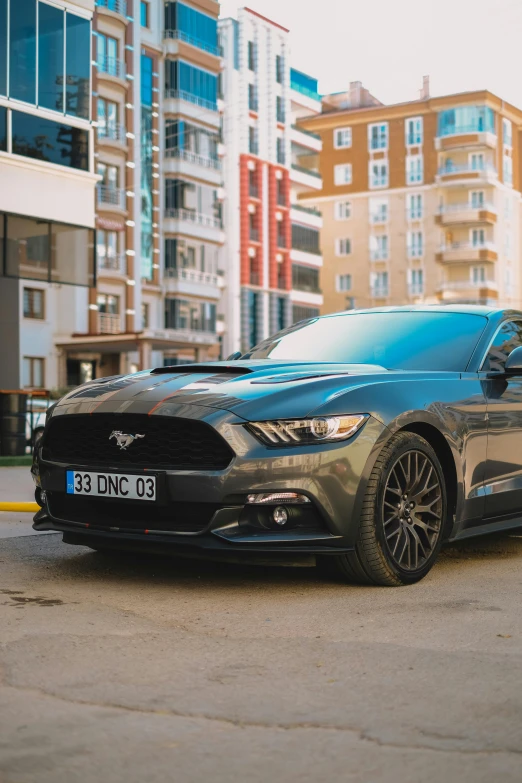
[220,8,323,355]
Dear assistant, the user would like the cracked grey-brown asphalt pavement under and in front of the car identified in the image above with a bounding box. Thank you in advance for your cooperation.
[0,468,522,783]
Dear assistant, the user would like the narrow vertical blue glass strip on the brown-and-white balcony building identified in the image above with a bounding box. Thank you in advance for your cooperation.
[141,54,154,280]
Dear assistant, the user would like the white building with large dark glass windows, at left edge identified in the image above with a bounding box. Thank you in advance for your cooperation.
[0,0,96,389]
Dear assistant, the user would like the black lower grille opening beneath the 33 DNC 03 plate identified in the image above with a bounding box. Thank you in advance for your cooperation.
[48,493,219,533]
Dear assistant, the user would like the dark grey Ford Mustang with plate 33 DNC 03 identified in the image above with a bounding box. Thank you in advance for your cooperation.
[32,306,522,586]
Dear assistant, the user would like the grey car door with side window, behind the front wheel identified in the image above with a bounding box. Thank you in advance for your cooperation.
[481,320,522,518]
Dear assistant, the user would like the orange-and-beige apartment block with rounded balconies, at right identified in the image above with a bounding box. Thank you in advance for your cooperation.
[300,80,522,313]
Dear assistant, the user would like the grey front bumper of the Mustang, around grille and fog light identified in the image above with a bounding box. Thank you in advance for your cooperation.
[33,406,385,555]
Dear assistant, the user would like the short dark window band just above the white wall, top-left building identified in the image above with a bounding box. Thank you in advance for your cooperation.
[11,111,89,171]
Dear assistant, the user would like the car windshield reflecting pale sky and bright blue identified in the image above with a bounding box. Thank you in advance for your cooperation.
[241,312,487,372]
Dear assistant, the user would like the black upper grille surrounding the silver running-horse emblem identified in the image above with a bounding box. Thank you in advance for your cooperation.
[43,413,234,470]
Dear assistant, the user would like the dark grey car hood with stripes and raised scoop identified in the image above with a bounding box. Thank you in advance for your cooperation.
[55,360,456,421]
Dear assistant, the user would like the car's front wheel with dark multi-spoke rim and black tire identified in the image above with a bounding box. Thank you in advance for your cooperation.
[321,432,448,587]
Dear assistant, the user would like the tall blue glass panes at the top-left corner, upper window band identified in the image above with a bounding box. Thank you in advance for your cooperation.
[0,0,91,119]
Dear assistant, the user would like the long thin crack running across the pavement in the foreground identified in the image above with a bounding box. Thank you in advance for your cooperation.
[0,685,522,756]
